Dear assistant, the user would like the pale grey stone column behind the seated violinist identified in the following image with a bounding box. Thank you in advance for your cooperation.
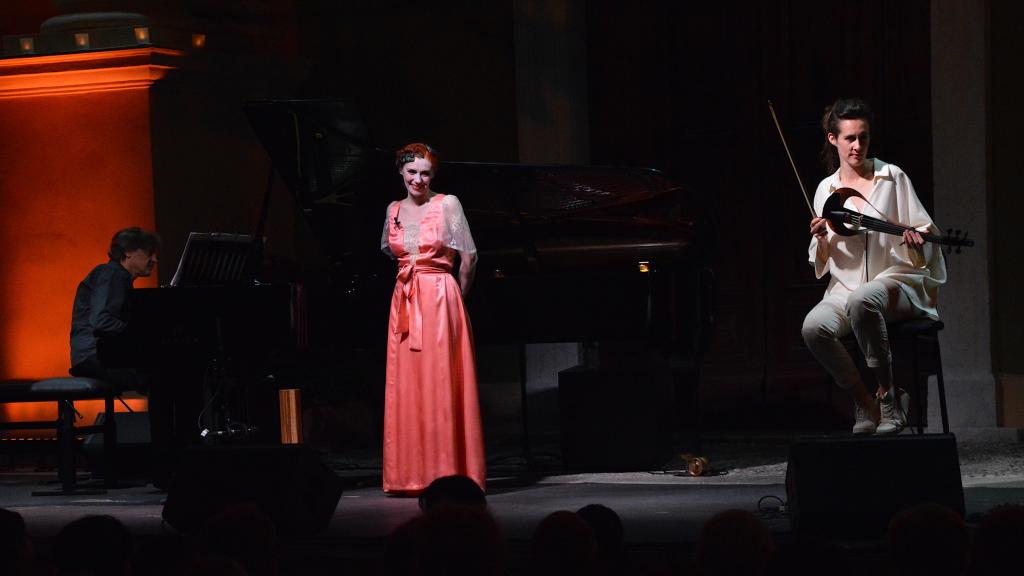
[928,0,998,440]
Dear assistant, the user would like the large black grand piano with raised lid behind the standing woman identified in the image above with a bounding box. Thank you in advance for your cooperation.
[110,99,710,457]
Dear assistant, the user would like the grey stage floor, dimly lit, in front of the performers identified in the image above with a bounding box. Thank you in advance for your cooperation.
[6,435,1024,569]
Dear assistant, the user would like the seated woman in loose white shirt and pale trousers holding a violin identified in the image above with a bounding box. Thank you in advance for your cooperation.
[802,98,946,435]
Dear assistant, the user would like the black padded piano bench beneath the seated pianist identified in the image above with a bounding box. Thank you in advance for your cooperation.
[0,377,118,496]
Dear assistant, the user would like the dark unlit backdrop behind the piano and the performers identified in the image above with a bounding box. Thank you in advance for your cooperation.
[0,0,1024,438]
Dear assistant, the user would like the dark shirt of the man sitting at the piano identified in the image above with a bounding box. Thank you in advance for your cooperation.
[71,260,133,370]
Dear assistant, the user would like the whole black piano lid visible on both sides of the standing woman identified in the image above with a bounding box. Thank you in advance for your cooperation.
[245,99,697,274]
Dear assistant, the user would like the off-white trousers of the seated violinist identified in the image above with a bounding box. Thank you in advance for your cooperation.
[801,278,925,389]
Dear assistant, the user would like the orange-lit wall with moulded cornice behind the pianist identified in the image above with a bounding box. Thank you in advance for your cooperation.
[0,48,182,432]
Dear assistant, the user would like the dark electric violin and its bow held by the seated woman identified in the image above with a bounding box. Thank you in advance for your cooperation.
[768,100,974,254]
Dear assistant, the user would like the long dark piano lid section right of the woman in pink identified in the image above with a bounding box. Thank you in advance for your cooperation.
[435,162,696,274]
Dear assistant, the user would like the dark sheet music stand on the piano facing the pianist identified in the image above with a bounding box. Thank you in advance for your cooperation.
[171,232,260,286]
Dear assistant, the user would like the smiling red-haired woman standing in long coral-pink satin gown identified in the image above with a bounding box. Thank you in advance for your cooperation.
[381,143,485,495]
